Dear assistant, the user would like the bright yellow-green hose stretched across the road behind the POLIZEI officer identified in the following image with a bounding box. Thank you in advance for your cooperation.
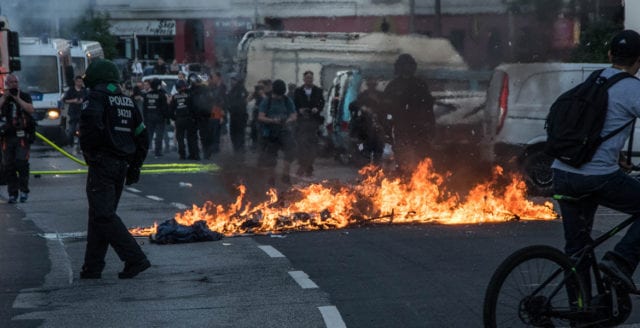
[30,131,220,175]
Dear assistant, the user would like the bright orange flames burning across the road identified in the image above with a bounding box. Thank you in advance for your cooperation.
[130,158,557,236]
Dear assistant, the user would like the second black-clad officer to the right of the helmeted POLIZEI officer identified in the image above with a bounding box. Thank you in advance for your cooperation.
[169,80,199,160]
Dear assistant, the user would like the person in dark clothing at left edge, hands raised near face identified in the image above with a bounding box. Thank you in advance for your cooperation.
[0,91,35,199]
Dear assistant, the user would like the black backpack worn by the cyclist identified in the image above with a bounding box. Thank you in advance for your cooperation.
[544,69,635,168]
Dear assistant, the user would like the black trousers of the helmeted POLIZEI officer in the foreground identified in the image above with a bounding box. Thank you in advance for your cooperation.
[84,155,146,272]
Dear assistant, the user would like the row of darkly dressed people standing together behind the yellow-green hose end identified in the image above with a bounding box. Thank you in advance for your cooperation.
[127,71,324,184]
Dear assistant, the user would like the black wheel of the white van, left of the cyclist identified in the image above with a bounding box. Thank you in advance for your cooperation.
[522,151,553,196]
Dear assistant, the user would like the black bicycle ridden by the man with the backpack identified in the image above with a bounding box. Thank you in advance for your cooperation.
[483,211,640,328]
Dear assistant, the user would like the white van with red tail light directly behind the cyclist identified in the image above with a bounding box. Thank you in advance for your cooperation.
[483,63,640,195]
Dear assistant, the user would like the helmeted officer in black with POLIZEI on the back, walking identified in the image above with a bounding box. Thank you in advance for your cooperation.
[79,59,151,279]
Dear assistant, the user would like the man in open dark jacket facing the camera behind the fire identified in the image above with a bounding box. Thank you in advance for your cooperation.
[293,71,324,177]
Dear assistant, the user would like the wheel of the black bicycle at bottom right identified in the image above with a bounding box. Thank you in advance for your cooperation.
[484,245,586,328]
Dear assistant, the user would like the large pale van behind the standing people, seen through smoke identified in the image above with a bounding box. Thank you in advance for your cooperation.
[236,31,490,165]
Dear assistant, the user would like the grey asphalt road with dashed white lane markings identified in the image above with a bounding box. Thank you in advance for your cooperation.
[0,145,640,328]
